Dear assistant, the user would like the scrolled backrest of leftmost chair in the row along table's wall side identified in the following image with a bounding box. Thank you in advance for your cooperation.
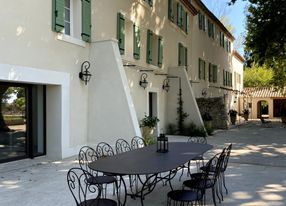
[78,146,97,174]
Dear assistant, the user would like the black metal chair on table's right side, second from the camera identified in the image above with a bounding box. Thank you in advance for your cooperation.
[183,150,225,205]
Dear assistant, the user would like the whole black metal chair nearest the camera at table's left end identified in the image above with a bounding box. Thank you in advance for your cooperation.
[67,168,119,206]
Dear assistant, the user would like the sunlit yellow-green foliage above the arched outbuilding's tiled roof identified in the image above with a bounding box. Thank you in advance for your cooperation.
[243,64,273,87]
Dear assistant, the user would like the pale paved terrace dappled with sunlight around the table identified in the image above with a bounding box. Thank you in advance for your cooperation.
[0,121,286,206]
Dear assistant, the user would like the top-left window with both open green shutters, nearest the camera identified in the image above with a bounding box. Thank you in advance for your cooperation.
[52,0,91,42]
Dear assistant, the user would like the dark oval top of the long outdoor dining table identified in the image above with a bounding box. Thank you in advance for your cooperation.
[89,142,212,175]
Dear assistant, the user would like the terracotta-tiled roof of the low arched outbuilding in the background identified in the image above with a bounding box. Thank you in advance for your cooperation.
[242,87,286,98]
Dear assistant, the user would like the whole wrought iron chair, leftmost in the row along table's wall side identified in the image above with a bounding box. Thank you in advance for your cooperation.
[78,146,116,197]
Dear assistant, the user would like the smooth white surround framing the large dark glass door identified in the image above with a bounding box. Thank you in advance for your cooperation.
[0,64,70,159]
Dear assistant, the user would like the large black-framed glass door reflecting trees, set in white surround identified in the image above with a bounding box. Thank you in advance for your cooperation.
[0,83,45,162]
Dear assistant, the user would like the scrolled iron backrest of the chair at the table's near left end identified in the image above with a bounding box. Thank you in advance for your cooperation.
[67,168,100,206]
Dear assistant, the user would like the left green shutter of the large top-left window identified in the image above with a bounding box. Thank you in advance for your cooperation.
[52,0,65,32]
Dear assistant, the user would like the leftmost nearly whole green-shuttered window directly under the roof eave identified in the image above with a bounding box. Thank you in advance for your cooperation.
[168,0,190,34]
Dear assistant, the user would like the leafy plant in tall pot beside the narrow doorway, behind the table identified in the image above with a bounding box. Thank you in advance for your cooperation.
[140,114,160,145]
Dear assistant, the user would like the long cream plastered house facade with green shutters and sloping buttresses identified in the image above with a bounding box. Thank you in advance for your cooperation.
[0,0,243,159]
